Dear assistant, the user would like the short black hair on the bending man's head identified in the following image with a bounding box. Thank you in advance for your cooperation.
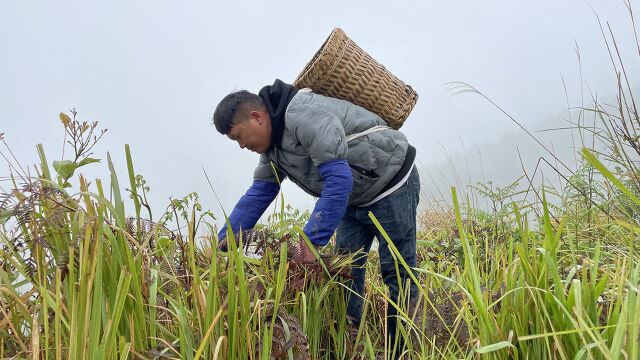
[213,90,266,135]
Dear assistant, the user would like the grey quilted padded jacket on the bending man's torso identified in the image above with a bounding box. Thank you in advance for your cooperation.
[254,91,409,206]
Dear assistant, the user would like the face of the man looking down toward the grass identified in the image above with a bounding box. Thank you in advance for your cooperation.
[227,111,271,154]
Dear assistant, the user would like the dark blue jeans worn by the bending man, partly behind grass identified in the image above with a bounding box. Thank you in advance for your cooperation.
[336,168,420,338]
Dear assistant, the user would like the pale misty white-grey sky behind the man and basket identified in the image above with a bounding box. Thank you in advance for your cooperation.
[0,0,640,226]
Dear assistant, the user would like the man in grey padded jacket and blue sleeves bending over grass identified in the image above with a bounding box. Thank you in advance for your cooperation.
[213,80,420,348]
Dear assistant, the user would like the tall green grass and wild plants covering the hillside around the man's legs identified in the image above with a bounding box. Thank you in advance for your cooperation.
[0,6,640,359]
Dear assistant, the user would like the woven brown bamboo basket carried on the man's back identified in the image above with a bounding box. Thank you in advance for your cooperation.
[293,28,418,129]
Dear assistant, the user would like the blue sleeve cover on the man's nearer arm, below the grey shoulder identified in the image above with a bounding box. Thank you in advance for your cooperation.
[304,159,353,246]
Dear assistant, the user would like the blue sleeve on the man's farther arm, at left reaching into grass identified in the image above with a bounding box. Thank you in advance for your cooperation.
[218,180,280,241]
